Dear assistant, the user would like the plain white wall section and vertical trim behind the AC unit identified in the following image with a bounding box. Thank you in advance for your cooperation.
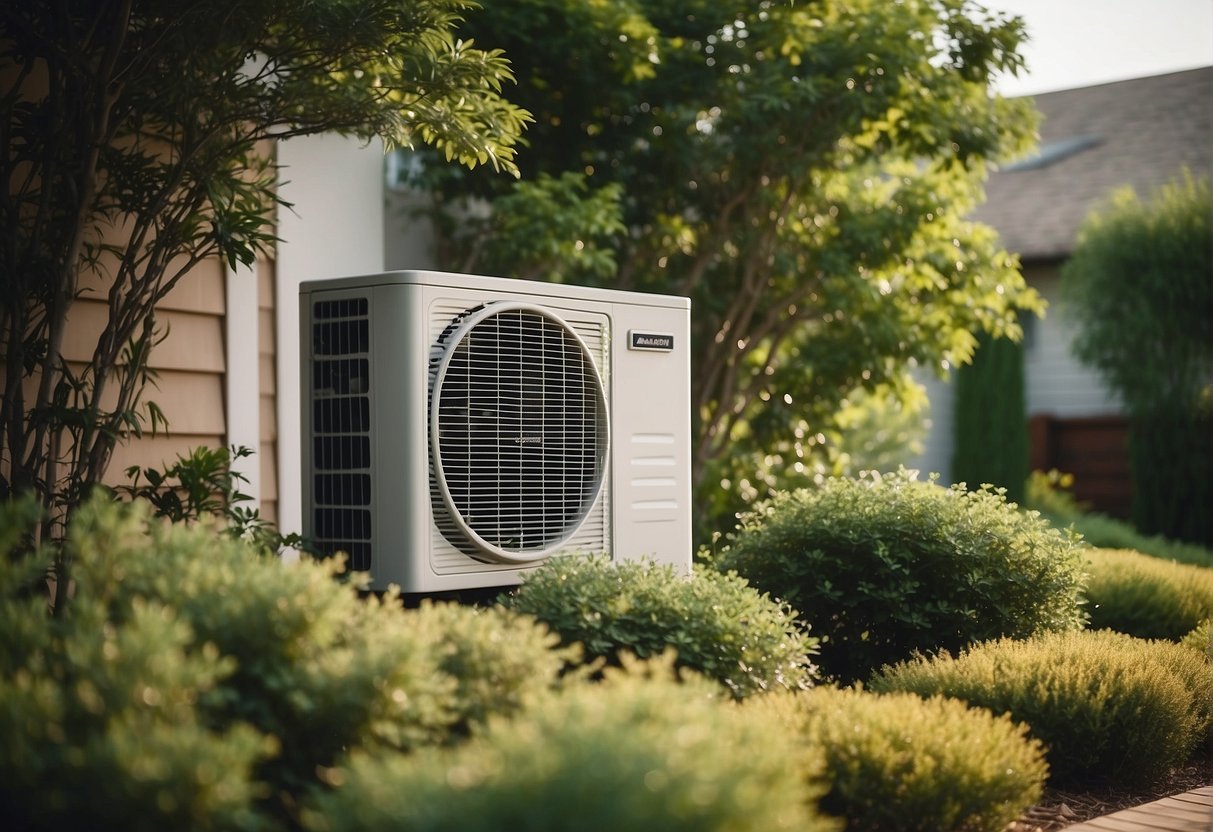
[274,130,383,532]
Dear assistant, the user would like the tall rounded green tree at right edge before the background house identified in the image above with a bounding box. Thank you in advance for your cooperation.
[1061,172,1213,546]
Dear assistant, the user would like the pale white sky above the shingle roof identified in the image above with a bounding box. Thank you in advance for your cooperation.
[978,0,1213,96]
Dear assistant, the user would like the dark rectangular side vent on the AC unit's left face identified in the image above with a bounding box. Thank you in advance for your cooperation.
[312,297,371,571]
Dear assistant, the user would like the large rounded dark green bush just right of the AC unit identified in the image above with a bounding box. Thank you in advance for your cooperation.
[711,472,1083,682]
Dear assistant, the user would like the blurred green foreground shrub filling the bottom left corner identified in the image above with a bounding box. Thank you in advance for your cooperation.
[0,506,274,831]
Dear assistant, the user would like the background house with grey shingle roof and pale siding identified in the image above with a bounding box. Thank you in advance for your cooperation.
[912,67,1213,517]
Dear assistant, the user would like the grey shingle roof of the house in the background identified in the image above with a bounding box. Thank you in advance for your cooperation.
[974,67,1213,261]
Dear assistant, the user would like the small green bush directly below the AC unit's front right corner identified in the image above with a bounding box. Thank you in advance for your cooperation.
[503,557,816,697]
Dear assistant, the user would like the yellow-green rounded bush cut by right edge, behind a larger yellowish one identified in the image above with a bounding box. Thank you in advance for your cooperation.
[1083,549,1213,642]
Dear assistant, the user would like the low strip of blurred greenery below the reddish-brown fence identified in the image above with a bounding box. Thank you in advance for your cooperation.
[1025,471,1213,568]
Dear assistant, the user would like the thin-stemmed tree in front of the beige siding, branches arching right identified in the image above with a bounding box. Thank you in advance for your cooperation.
[0,0,528,543]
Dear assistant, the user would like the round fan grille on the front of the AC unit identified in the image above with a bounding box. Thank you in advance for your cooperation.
[431,303,609,560]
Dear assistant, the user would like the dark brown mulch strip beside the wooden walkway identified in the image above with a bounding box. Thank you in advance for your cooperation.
[1006,756,1213,832]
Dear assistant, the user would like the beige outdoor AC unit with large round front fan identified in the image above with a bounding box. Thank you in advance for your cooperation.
[300,272,691,593]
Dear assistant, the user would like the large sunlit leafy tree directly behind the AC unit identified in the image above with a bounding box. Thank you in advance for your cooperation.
[412,0,1040,538]
